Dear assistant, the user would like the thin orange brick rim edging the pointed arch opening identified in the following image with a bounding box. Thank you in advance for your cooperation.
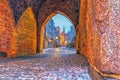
[38,11,74,52]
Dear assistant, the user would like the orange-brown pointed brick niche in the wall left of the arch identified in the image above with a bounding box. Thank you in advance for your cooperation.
[15,7,37,56]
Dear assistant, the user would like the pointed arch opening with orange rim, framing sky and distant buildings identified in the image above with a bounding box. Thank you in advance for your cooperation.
[39,11,76,52]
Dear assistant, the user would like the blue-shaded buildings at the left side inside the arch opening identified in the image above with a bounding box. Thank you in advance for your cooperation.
[44,19,60,47]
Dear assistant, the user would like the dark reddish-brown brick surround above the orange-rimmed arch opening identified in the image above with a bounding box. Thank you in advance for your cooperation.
[37,0,79,53]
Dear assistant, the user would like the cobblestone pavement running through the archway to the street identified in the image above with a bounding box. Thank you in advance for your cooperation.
[0,48,91,80]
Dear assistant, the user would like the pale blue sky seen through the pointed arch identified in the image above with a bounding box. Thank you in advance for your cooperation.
[52,14,73,33]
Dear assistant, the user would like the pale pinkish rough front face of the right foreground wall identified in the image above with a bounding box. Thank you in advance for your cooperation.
[97,0,120,74]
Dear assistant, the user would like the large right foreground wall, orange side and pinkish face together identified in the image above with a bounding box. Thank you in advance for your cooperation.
[87,0,120,74]
